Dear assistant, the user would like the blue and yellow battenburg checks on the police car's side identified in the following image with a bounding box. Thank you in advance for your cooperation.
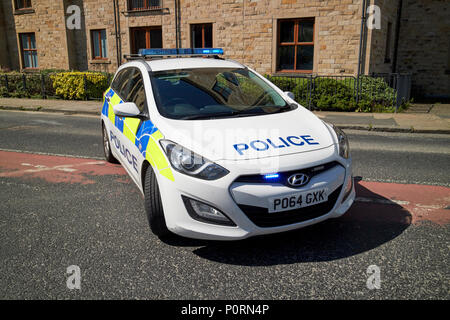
[102,88,175,181]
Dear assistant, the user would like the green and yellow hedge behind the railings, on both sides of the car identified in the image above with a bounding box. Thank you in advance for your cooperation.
[0,69,407,112]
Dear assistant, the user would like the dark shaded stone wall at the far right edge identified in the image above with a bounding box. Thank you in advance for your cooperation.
[398,0,450,97]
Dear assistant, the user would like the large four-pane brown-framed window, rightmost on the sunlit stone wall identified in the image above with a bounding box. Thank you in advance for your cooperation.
[277,19,314,72]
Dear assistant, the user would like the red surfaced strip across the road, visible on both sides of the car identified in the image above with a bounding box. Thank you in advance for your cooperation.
[0,151,450,225]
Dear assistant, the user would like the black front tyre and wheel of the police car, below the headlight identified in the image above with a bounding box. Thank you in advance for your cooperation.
[144,166,170,237]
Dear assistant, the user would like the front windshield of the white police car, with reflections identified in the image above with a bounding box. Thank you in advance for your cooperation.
[151,68,294,120]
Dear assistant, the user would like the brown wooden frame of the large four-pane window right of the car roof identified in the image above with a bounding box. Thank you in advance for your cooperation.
[275,17,316,74]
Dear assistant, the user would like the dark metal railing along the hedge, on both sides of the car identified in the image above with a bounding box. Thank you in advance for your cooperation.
[0,73,411,111]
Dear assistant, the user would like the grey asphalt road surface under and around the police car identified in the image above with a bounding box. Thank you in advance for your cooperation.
[0,111,450,299]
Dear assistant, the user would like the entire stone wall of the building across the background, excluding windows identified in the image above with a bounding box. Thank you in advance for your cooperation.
[0,0,450,95]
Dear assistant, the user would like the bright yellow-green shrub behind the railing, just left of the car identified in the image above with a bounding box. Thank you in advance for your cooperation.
[50,72,109,100]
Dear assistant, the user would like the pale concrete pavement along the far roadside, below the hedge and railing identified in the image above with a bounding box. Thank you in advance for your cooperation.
[0,98,450,134]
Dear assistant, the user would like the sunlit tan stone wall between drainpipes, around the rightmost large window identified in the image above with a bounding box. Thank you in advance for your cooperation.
[181,0,361,74]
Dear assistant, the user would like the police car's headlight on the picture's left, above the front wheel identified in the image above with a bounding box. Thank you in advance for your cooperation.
[159,139,229,180]
